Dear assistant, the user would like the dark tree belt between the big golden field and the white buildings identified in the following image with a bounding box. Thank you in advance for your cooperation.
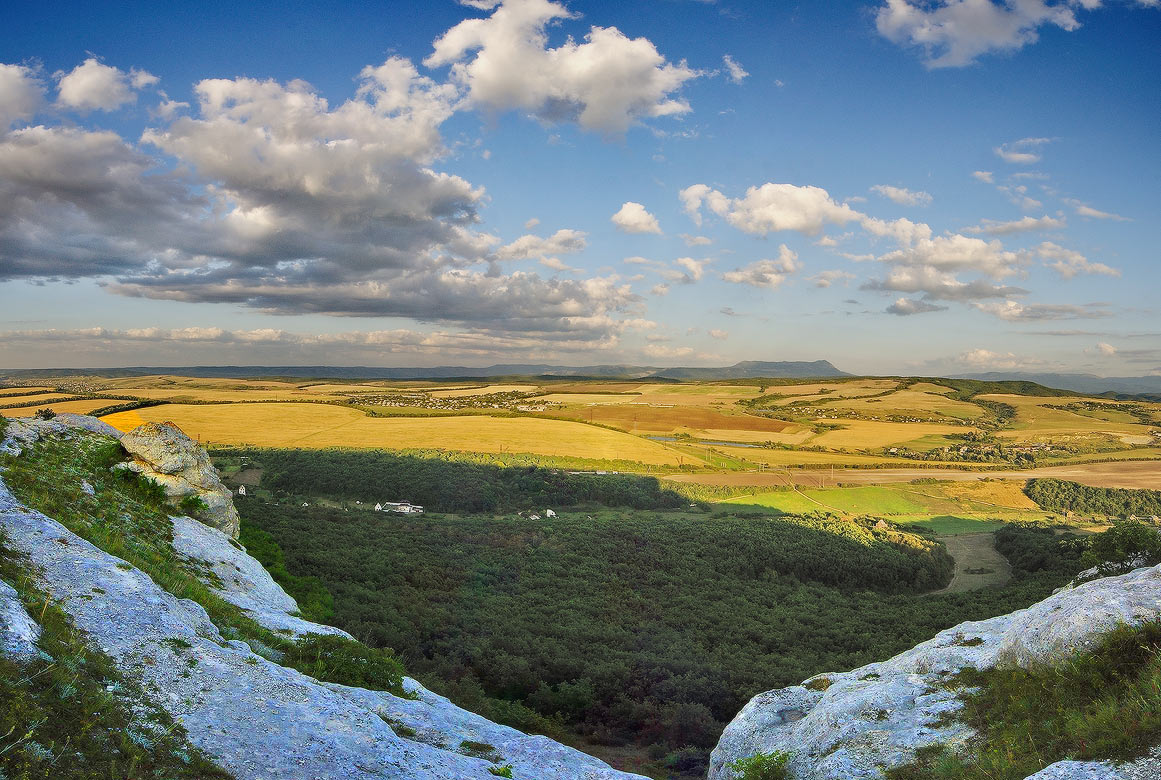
[226,449,688,512]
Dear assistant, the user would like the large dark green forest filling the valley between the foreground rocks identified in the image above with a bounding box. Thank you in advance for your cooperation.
[239,496,1072,767]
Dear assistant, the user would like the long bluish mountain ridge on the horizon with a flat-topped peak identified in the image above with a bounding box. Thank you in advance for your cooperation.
[0,360,851,380]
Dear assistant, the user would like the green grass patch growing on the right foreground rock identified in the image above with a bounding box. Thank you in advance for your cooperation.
[887,622,1161,780]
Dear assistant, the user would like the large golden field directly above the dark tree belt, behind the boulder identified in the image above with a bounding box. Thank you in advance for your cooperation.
[104,404,693,465]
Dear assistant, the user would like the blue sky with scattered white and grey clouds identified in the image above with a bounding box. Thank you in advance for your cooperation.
[0,0,1161,375]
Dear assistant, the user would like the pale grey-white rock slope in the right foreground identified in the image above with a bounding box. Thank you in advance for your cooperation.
[709,565,1161,780]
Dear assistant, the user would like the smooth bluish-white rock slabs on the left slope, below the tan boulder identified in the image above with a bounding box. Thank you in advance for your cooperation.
[0,413,644,780]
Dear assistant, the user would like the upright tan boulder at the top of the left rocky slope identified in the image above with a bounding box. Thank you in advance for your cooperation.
[117,423,239,539]
